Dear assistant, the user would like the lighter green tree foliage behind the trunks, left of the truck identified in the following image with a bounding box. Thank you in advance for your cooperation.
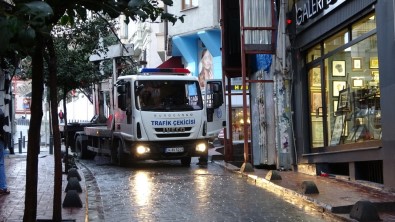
[54,15,116,98]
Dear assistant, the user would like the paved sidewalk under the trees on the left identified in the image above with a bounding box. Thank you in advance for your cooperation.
[0,146,87,222]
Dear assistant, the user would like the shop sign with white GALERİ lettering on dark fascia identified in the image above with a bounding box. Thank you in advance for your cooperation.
[295,0,346,26]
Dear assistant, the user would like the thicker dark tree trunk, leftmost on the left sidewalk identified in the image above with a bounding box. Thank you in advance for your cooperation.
[23,34,44,222]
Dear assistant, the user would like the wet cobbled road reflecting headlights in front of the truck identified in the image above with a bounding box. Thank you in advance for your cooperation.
[81,159,334,221]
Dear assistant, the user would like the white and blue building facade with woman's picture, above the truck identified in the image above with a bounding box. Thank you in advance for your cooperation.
[168,0,222,85]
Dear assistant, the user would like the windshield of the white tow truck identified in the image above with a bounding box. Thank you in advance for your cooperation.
[135,80,203,112]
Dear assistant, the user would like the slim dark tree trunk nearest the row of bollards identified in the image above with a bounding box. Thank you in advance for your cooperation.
[47,38,62,221]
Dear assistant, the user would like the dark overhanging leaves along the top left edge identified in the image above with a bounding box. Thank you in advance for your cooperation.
[0,0,184,57]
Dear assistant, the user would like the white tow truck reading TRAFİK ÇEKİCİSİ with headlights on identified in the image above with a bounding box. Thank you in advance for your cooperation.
[74,68,226,166]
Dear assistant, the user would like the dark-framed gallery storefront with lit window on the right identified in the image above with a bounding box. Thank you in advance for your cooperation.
[291,0,395,189]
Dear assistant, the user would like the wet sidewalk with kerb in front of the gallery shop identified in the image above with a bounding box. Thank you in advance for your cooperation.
[210,148,395,221]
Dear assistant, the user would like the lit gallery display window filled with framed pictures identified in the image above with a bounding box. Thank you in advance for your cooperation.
[306,14,381,149]
